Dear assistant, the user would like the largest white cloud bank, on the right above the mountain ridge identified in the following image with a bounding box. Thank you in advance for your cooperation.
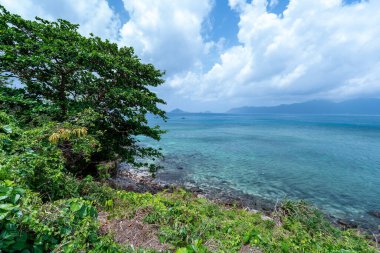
[169,0,380,105]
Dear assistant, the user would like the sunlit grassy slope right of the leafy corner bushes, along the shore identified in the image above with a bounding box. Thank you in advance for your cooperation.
[95,186,377,253]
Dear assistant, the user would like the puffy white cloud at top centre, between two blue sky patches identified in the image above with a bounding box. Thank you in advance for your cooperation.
[120,0,213,76]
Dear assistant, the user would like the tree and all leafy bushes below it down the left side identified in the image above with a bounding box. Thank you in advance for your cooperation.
[0,6,165,252]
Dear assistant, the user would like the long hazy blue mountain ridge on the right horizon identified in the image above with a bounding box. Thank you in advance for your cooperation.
[227,98,380,115]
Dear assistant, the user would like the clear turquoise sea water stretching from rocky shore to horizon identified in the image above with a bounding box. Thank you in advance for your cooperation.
[145,114,380,226]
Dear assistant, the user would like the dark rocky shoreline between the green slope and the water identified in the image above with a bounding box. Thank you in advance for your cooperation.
[109,164,380,241]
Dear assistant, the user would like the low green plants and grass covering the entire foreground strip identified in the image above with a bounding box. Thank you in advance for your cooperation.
[0,174,378,253]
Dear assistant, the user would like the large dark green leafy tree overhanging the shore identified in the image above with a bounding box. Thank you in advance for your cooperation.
[0,6,166,176]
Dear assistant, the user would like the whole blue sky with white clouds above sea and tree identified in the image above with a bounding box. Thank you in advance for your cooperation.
[0,0,380,112]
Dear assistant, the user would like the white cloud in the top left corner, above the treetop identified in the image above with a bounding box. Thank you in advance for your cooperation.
[0,0,120,41]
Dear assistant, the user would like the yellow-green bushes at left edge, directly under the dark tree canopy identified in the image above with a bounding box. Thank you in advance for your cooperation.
[0,112,88,200]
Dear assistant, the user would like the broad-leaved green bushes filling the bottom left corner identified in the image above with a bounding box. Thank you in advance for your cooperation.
[0,181,154,253]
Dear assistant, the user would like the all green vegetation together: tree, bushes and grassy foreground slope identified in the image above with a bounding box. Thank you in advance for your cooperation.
[0,6,375,252]
